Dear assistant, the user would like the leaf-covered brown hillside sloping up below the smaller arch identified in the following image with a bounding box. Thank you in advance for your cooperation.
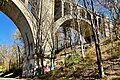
[31,38,120,80]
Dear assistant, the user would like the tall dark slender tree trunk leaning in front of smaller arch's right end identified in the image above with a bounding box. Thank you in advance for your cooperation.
[84,0,104,78]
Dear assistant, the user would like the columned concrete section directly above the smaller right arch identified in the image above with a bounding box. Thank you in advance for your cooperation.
[55,0,100,24]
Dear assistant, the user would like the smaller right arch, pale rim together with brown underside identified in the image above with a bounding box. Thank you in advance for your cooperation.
[54,15,93,37]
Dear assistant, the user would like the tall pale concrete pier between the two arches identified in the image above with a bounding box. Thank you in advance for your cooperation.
[32,0,54,74]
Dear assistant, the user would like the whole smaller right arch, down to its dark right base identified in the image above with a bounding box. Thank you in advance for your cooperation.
[55,15,93,48]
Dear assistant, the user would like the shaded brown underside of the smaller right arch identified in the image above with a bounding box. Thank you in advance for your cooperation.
[61,19,93,42]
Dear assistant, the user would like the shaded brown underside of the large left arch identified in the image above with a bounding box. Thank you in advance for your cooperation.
[1,0,34,53]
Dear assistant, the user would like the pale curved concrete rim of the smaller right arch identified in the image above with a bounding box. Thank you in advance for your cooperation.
[53,15,92,37]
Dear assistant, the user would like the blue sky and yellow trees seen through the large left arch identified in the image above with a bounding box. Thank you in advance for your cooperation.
[0,11,25,77]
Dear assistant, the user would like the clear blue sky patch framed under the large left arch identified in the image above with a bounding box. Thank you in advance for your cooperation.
[0,11,17,45]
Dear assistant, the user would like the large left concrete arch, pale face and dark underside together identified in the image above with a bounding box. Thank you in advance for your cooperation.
[1,0,36,55]
